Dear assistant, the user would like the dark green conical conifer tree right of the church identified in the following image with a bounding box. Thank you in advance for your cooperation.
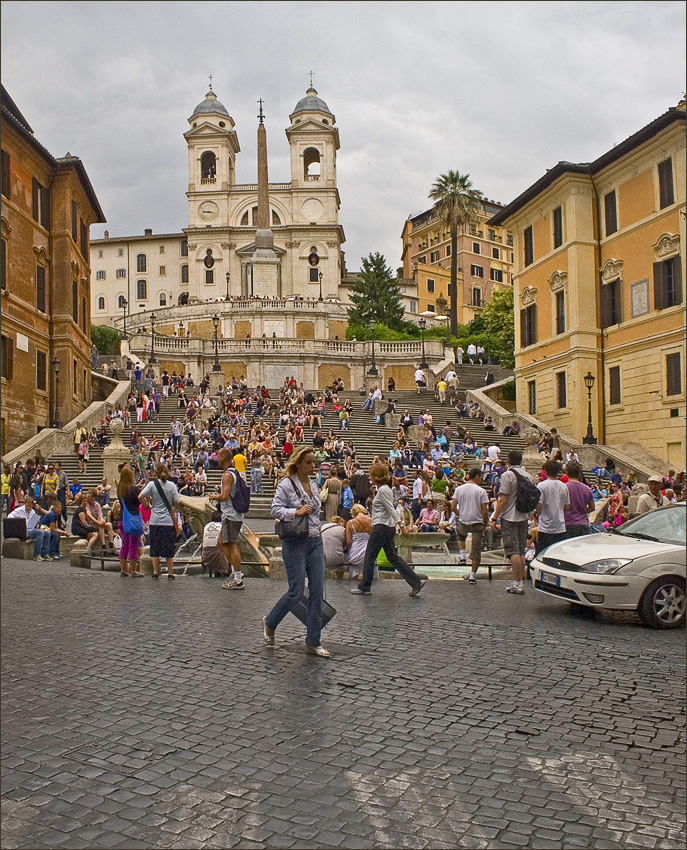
[348,252,406,331]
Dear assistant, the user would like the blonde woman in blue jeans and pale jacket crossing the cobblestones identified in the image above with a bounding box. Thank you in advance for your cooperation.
[262,445,330,658]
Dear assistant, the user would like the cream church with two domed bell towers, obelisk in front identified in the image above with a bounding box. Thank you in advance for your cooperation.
[184,85,344,303]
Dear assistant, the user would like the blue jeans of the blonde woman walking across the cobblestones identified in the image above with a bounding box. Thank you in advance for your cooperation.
[266,537,324,646]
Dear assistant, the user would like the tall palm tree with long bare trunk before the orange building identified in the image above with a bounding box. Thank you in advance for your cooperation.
[429,171,482,336]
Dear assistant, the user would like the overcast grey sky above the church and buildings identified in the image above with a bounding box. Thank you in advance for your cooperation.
[2,0,685,270]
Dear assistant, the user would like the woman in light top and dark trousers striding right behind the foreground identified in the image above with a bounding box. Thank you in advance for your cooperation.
[351,463,426,596]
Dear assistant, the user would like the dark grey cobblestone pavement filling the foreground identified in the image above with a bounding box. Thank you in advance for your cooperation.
[2,561,685,850]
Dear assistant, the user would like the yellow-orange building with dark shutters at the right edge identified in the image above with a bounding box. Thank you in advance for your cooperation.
[490,101,685,469]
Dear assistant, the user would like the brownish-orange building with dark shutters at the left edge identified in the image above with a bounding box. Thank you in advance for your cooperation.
[0,87,105,454]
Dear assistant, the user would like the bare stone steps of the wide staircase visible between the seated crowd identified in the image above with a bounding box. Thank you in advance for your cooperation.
[40,365,594,518]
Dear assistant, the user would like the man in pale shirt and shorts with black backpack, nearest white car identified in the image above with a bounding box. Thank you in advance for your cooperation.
[489,451,534,596]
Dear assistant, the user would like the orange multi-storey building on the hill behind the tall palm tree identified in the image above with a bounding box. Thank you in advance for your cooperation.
[401,200,513,324]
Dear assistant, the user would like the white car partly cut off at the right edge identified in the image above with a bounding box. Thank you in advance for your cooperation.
[530,503,687,629]
